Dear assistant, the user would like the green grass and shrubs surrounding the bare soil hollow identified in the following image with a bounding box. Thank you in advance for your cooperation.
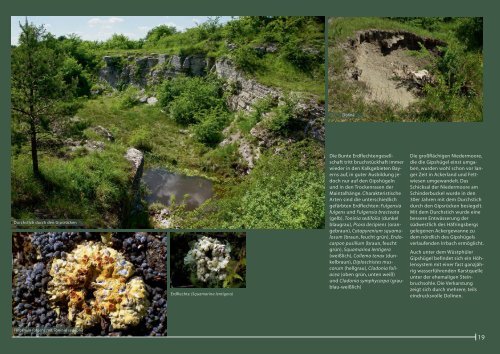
[328,17,483,122]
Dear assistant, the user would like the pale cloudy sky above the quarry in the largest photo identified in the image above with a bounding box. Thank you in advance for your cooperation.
[10,16,231,44]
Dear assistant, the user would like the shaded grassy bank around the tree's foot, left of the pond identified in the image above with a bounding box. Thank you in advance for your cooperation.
[11,133,130,227]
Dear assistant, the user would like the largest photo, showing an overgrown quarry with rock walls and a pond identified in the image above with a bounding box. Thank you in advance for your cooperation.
[11,16,325,229]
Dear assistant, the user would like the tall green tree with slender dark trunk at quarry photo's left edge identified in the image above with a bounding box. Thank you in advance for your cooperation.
[11,19,72,178]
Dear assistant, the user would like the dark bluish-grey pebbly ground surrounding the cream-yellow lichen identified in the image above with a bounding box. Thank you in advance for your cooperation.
[12,232,167,336]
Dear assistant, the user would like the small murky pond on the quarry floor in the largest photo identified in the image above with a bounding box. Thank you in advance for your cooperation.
[142,168,213,210]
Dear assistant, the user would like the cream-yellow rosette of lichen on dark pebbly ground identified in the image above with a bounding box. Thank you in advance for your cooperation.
[47,242,149,330]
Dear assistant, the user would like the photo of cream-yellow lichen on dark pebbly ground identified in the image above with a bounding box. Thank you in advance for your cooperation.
[12,232,167,336]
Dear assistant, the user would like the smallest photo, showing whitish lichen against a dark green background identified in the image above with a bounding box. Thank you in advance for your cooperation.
[170,232,247,288]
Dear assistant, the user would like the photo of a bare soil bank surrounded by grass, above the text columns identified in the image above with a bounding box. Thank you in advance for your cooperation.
[328,17,483,122]
